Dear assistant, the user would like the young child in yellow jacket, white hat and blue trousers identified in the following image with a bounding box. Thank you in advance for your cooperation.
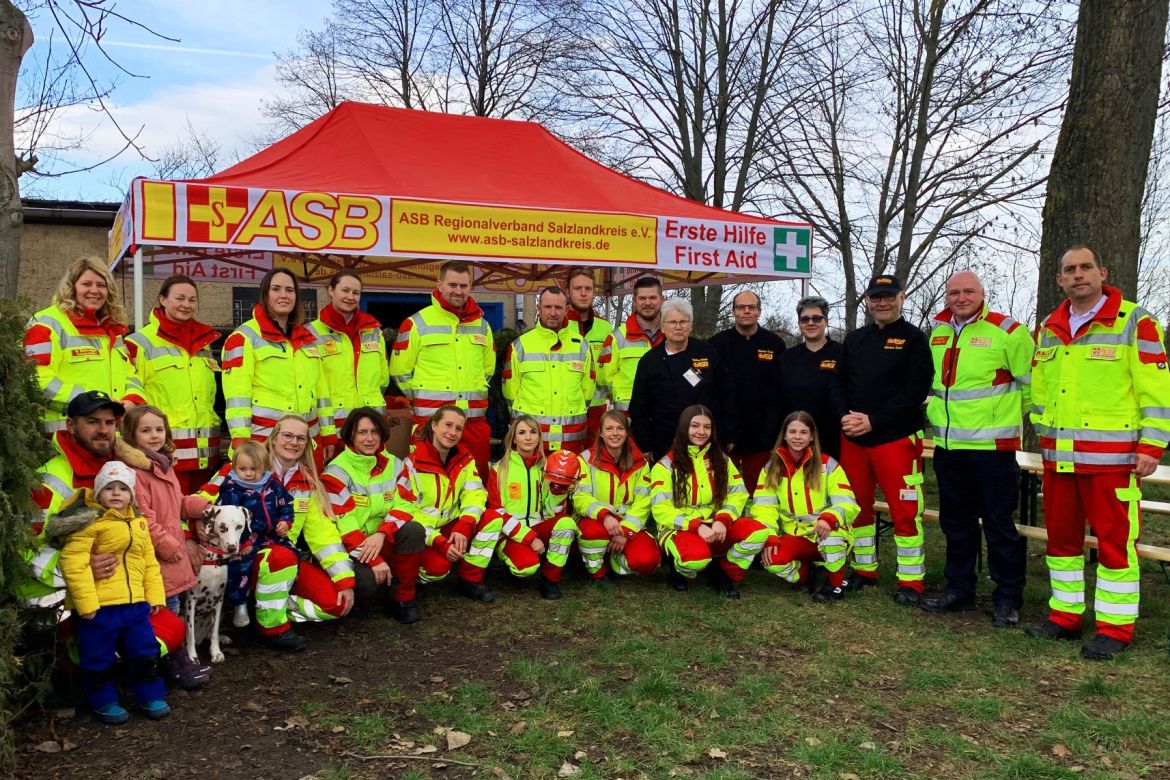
[54,461,171,724]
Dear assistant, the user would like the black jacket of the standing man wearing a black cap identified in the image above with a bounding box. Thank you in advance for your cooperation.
[833,319,935,447]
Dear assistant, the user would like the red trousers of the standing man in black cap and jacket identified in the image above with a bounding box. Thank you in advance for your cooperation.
[841,435,926,593]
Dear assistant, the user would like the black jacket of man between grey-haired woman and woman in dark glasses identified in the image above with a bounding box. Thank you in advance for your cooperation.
[710,327,786,451]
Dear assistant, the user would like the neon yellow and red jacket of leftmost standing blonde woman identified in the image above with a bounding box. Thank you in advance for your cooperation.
[25,305,145,434]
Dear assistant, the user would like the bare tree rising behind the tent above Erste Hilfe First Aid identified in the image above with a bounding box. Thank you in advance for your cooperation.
[556,0,833,331]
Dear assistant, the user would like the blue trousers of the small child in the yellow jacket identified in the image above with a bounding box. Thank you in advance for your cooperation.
[74,601,166,710]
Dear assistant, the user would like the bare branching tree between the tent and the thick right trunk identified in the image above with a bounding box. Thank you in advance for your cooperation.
[768,0,1072,329]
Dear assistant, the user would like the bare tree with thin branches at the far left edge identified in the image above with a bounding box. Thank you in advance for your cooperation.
[0,0,173,298]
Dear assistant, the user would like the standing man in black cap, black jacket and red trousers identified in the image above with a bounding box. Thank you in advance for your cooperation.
[832,274,934,606]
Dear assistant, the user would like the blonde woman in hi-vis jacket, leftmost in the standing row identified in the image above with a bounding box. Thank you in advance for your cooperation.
[25,257,145,434]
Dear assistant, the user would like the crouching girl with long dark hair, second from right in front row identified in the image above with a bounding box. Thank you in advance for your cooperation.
[651,403,768,599]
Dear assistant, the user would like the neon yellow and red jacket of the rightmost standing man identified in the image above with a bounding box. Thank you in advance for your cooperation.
[1032,285,1170,474]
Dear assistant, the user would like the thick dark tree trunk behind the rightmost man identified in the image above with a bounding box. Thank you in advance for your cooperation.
[1037,0,1170,319]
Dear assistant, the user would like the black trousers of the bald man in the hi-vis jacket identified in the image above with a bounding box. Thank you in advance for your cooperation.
[934,447,1027,609]
